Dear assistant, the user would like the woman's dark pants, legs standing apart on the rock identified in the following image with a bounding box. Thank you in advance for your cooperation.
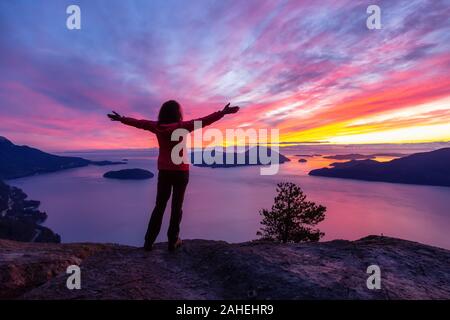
[145,170,189,245]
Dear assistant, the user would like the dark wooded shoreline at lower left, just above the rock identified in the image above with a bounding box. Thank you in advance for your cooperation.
[0,180,61,243]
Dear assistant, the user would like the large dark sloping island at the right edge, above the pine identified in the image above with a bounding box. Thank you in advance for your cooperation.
[309,148,450,187]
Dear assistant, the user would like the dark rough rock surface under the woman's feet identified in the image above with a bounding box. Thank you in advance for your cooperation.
[0,236,450,299]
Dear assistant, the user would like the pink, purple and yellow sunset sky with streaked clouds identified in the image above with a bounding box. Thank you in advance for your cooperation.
[0,0,450,150]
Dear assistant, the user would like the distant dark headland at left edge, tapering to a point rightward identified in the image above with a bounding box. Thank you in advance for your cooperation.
[0,137,126,180]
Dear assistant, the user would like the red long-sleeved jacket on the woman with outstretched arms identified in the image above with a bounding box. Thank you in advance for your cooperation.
[121,111,224,171]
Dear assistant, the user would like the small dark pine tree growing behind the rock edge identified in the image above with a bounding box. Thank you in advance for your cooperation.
[257,182,326,243]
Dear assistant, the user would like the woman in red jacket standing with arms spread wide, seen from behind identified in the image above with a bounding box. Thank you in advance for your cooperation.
[108,100,239,251]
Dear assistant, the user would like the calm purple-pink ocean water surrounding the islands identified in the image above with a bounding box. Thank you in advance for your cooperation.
[8,144,450,249]
